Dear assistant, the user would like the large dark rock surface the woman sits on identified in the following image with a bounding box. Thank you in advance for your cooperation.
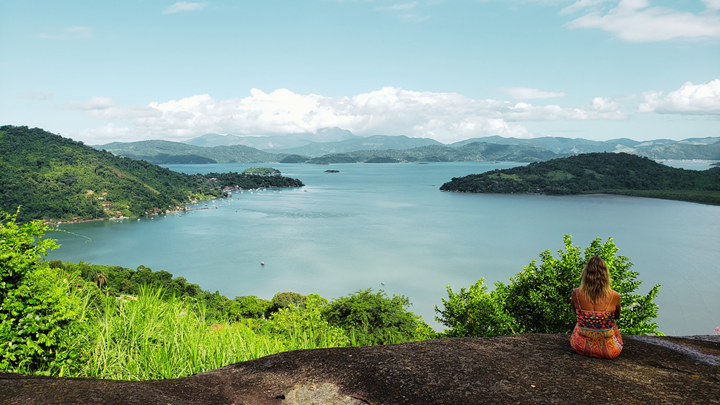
[0,335,720,405]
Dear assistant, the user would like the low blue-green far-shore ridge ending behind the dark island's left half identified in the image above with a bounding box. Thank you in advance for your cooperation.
[307,142,560,163]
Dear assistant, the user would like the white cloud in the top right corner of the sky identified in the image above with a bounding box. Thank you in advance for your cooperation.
[561,0,720,42]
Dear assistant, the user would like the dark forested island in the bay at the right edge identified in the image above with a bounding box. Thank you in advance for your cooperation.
[440,153,720,204]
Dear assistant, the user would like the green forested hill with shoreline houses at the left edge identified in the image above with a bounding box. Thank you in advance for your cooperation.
[0,126,228,222]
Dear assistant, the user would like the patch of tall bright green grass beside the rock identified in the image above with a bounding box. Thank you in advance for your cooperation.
[77,289,347,380]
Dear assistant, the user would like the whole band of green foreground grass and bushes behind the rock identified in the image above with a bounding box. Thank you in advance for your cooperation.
[0,207,659,380]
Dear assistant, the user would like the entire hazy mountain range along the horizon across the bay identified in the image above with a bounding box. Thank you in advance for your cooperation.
[94,128,720,164]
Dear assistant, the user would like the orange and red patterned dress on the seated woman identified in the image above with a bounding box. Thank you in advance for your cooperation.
[570,289,623,359]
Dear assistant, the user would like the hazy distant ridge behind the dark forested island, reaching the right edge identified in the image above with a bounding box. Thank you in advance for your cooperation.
[449,136,720,159]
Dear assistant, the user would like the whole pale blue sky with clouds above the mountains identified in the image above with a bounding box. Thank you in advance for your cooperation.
[0,0,720,144]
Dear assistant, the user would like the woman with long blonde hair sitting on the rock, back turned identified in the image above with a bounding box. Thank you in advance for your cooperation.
[570,256,623,359]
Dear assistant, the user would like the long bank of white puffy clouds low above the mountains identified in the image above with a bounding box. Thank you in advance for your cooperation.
[70,87,627,142]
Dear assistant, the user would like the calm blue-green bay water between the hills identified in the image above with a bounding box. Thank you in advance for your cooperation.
[48,162,720,335]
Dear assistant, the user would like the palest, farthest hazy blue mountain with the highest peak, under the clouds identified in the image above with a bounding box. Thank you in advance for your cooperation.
[184,127,360,151]
